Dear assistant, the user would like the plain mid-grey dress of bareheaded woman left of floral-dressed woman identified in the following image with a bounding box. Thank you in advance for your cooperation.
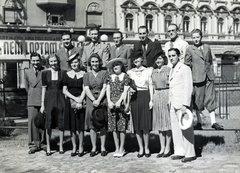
[83,70,107,130]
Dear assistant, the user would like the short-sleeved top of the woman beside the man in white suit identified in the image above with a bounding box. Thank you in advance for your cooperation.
[152,65,171,89]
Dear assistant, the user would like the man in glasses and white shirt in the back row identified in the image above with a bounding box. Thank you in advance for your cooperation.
[164,23,188,67]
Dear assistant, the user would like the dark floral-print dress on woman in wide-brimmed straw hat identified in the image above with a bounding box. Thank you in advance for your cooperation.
[107,73,130,132]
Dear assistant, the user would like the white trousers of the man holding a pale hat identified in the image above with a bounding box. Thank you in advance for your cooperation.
[170,106,196,157]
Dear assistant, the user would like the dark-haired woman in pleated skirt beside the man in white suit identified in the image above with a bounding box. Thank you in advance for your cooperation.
[152,51,171,158]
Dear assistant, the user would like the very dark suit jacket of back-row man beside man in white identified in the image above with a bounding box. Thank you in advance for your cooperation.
[133,38,162,67]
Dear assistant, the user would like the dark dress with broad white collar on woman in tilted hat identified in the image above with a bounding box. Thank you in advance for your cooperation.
[63,73,85,132]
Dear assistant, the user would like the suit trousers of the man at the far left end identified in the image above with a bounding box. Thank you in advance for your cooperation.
[28,106,44,147]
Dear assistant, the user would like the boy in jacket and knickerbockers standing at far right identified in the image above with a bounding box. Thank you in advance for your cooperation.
[184,29,223,130]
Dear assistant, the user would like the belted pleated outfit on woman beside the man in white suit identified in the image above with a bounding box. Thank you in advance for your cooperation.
[152,66,171,131]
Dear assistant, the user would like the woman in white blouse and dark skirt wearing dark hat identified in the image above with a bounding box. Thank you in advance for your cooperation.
[127,51,153,158]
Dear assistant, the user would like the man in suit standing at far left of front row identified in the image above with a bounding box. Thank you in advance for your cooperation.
[25,53,44,154]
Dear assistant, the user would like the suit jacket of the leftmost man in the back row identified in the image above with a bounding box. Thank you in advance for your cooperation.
[56,47,82,71]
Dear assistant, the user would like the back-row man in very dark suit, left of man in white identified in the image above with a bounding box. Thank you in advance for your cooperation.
[133,26,162,67]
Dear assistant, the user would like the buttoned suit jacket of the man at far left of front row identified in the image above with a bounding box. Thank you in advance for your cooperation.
[24,66,44,106]
